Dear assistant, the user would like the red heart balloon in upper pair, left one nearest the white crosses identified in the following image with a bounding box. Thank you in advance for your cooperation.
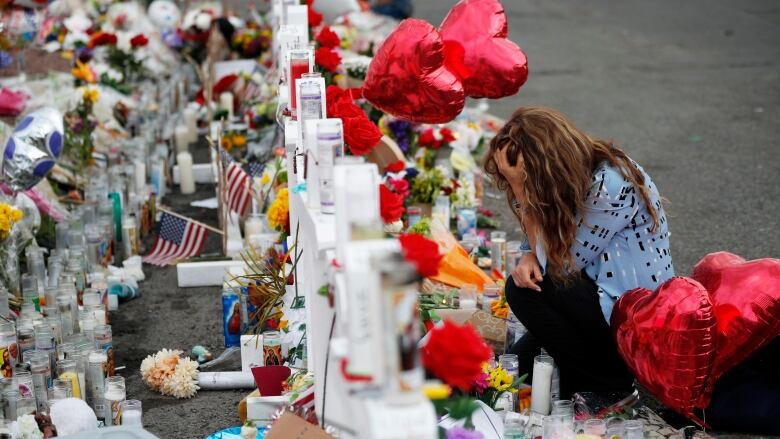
[363,19,466,123]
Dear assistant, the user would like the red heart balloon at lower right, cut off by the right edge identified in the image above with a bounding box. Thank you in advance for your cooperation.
[693,252,780,385]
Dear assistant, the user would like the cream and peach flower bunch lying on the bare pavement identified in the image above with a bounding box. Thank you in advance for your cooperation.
[141,349,199,398]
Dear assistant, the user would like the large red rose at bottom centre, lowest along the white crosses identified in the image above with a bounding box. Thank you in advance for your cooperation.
[422,320,493,392]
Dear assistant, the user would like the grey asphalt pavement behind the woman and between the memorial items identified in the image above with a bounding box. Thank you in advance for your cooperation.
[112,0,780,439]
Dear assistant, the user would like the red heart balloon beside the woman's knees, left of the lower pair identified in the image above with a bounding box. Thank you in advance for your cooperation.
[612,277,717,419]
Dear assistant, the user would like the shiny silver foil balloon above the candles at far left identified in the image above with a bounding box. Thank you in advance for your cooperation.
[2,108,65,192]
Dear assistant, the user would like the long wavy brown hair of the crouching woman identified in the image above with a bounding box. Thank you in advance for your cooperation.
[484,107,659,280]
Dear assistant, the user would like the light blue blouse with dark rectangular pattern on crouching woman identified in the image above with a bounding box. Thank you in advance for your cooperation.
[526,163,674,322]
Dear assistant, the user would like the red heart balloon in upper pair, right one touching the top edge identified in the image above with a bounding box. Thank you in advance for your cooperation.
[439,0,528,99]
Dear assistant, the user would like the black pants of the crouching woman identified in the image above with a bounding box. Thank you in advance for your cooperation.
[506,273,634,398]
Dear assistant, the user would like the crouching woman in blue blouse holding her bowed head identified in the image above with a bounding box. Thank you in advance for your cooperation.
[485,108,674,398]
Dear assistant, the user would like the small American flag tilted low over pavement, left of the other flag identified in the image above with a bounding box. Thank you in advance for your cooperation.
[143,212,208,266]
